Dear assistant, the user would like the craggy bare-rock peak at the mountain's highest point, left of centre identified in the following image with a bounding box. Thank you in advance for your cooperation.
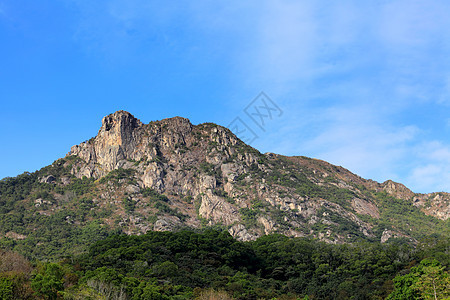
[69,110,216,182]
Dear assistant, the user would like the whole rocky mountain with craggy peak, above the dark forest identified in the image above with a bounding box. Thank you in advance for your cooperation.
[0,111,450,257]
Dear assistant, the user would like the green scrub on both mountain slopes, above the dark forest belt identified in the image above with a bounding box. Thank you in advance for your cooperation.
[0,150,450,260]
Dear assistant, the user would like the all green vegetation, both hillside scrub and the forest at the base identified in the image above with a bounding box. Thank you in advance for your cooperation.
[0,138,450,299]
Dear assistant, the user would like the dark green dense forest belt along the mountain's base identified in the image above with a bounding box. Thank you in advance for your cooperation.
[75,230,442,299]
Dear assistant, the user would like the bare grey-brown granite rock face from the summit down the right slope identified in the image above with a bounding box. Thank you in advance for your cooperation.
[64,111,450,243]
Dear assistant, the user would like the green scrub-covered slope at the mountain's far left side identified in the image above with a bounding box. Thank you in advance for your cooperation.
[0,162,118,259]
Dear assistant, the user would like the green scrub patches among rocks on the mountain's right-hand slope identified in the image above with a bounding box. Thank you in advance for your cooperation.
[260,157,450,242]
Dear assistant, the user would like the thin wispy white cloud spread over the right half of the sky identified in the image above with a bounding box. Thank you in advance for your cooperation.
[241,1,450,191]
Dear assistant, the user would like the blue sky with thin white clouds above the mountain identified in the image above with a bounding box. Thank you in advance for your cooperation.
[0,0,450,192]
